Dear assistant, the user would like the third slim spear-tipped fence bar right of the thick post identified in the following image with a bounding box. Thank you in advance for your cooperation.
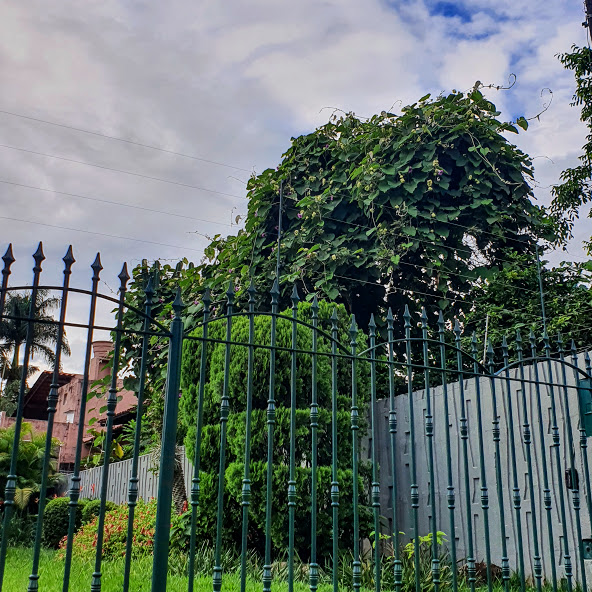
[241,280,257,592]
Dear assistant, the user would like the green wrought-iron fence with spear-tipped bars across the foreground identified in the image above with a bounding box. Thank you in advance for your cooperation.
[0,245,592,592]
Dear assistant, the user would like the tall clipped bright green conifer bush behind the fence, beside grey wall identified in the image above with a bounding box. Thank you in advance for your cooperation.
[179,302,369,559]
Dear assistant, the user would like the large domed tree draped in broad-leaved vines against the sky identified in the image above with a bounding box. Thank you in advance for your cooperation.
[201,88,555,325]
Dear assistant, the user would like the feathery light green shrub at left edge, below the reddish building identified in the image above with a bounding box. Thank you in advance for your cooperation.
[0,422,60,505]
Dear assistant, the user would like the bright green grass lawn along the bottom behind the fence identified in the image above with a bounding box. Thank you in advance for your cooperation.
[4,548,332,592]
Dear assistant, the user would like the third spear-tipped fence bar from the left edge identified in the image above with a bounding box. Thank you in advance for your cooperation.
[27,245,75,592]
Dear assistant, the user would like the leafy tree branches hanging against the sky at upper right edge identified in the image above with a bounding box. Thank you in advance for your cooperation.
[551,45,592,252]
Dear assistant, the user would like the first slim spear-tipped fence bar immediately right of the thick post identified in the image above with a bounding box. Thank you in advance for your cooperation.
[187,288,212,592]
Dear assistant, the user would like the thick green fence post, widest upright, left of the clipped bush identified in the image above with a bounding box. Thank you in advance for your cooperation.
[152,289,183,592]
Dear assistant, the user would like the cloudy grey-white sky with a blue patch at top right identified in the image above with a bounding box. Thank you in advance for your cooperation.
[0,0,590,370]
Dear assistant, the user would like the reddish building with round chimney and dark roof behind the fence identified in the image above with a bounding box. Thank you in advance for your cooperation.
[0,341,137,472]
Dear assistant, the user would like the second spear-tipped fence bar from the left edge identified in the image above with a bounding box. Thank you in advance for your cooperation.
[0,243,45,592]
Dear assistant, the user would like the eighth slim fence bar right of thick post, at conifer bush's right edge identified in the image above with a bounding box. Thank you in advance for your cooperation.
[349,315,362,592]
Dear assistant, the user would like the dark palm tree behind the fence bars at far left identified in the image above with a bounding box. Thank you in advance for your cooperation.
[0,290,70,400]
